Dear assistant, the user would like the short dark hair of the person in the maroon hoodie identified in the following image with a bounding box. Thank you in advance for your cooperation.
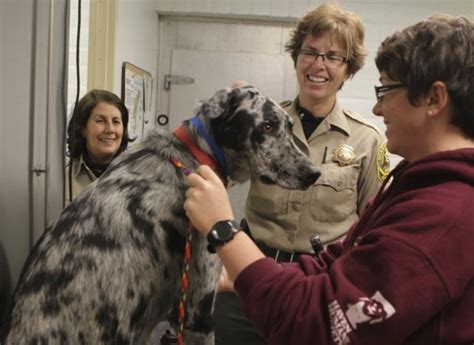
[375,15,474,138]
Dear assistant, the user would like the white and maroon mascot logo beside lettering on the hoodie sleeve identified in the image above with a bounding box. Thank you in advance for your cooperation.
[346,291,395,330]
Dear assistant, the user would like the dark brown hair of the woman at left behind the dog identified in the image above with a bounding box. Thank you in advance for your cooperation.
[66,90,133,159]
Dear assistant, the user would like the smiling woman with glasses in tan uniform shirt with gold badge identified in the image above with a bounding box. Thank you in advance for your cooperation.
[214,4,389,345]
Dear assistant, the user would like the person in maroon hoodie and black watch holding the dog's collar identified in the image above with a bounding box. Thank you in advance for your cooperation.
[185,15,474,345]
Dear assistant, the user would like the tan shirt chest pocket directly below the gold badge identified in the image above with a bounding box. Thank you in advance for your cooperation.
[309,164,360,222]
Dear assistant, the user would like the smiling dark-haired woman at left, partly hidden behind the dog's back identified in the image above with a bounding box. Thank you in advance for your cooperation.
[65,90,131,202]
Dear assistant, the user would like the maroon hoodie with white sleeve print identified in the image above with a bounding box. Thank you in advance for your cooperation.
[235,149,474,345]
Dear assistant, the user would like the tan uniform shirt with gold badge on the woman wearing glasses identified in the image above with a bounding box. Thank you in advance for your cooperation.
[245,101,386,252]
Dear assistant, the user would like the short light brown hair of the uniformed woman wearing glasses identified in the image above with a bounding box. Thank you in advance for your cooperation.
[285,3,367,77]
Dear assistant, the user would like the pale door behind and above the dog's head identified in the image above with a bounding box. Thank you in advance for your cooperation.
[169,49,284,129]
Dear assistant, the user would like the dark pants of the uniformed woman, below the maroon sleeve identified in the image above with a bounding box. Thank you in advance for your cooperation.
[213,292,266,345]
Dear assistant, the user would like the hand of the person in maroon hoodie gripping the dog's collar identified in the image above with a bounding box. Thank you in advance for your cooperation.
[184,165,234,235]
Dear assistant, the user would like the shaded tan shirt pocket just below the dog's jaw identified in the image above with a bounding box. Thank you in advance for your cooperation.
[247,181,290,217]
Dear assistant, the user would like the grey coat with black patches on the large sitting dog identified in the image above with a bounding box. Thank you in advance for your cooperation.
[2,87,319,345]
